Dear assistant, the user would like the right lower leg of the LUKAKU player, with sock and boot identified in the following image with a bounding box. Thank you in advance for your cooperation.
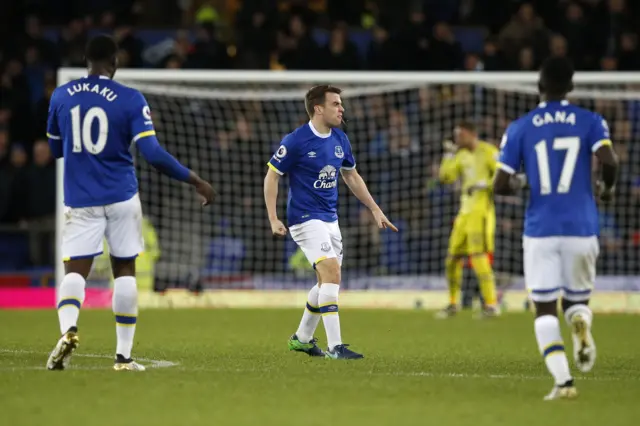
[111,256,145,371]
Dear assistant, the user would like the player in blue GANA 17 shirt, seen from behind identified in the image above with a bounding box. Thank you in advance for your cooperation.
[494,58,618,400]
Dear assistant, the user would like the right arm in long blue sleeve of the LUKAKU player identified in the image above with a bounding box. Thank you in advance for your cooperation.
[137,136,216,206]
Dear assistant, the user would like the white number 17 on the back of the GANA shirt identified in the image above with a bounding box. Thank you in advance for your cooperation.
[535,137,580,195]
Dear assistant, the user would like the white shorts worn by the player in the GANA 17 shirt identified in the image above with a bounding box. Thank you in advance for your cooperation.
[522,236,600,302]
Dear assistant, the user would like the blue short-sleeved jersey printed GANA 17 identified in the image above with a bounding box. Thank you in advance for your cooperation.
[498,101,611,237]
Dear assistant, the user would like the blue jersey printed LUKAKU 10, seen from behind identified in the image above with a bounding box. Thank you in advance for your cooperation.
[47,76,155,207]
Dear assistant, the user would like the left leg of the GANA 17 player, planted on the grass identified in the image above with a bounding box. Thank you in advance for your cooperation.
[534,300,578,401]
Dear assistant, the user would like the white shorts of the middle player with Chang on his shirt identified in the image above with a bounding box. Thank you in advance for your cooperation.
[289,219,342,269]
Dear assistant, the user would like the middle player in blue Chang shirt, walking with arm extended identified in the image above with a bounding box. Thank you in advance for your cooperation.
[264,85,397,359]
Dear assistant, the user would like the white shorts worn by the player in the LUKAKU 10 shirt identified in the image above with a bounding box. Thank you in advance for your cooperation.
[62,194,144,261]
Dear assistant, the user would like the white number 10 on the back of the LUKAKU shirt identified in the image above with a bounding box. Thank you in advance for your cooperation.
[71,105,109,155]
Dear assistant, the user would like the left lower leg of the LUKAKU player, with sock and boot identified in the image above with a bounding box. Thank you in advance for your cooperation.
[47,256,93,370]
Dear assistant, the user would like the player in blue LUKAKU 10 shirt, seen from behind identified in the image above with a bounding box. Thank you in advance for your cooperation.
[47,35,215,371]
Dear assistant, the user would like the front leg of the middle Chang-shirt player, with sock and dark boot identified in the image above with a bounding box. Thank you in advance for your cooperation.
[316,257,364,359]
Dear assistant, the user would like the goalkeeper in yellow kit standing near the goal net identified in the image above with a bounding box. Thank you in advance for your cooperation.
[438,122,499,318]
